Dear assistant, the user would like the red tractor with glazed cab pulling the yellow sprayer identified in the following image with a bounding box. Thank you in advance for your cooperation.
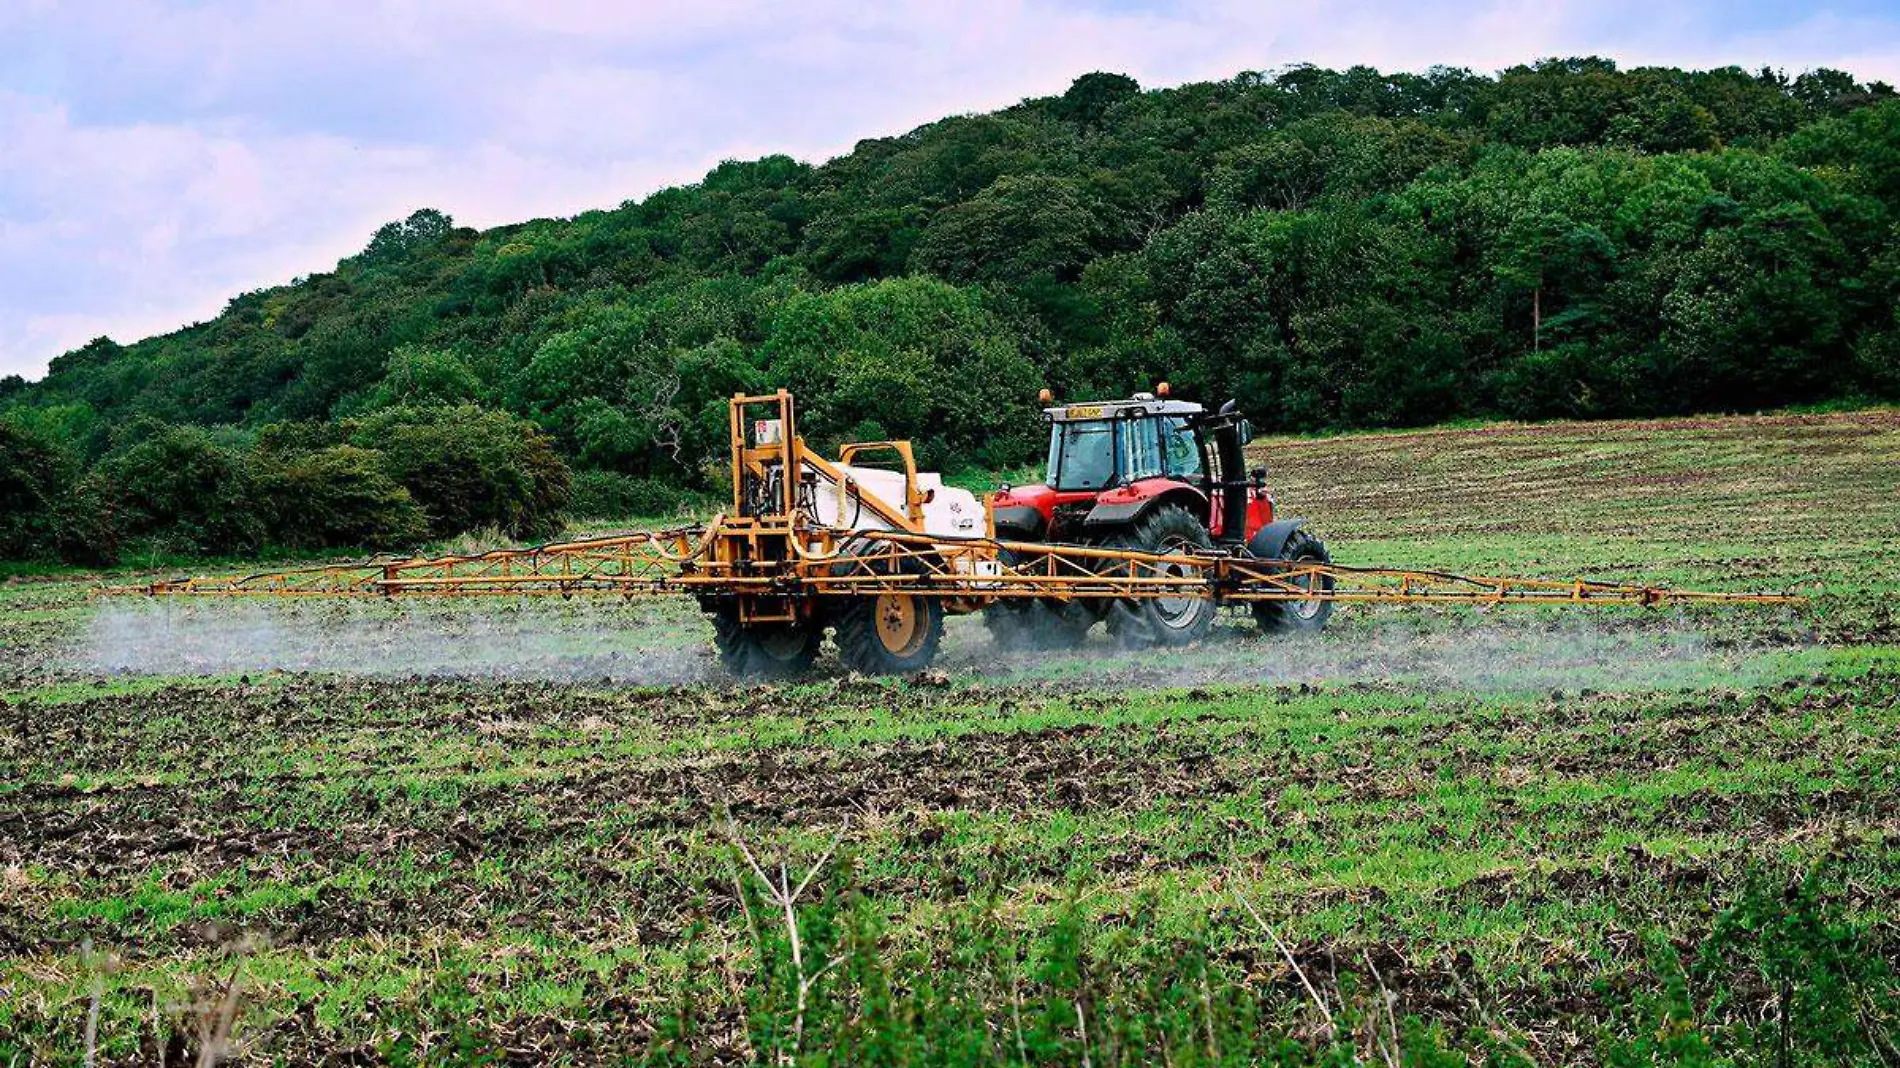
[984,382,1332,648]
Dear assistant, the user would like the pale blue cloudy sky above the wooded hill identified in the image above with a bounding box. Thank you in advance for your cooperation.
[0,0,1900,378]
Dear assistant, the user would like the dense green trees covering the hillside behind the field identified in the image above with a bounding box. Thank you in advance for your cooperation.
[0,59,1900,553]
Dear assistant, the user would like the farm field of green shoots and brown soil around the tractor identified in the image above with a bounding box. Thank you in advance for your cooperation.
[0,412,1900,1064]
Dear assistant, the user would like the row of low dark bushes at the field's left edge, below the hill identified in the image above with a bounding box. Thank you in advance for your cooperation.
[0,407,570,564]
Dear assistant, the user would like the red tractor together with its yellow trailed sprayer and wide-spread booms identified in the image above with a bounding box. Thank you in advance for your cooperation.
[103,382,1801,677]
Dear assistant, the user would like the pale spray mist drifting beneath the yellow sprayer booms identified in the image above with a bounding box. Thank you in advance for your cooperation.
[74,599,1801,692]
